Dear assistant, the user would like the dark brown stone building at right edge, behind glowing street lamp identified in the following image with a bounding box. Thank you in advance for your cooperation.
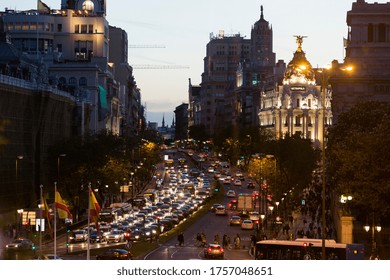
[330,0,390,123]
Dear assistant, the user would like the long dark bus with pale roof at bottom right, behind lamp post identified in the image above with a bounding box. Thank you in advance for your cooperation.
[255,238,364,260]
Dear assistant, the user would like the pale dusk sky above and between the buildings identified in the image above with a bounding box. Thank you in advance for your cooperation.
[0,0,368,125]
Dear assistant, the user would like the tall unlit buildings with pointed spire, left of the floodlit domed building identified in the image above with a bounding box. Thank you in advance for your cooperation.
[189,6,284,137]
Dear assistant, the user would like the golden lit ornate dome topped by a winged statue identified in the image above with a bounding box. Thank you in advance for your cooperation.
[283,36,315,85]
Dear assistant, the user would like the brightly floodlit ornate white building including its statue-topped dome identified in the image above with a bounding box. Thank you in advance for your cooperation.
[259,36,332,146]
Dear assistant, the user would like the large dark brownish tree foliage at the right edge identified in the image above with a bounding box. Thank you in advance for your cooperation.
[327,102,390,222]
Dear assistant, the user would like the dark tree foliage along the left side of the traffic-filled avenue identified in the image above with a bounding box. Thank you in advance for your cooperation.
[48,132,159,220]
